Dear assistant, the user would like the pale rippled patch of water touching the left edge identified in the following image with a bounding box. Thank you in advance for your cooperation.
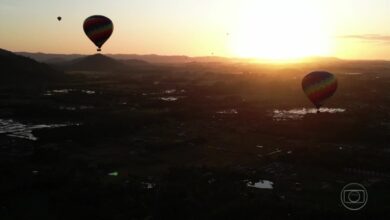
[0,119,79,141]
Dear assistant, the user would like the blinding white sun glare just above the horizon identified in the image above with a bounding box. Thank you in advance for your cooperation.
[230,0,331,60]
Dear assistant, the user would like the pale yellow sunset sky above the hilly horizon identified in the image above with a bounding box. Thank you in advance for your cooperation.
[0,0,390,60]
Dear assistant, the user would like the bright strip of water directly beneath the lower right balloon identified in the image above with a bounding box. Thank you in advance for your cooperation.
[272,108,346,121]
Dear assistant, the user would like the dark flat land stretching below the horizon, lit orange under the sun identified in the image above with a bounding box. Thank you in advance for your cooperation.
[0,54,390,220]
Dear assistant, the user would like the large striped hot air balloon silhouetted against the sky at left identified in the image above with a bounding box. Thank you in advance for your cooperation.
[83,15,114,51]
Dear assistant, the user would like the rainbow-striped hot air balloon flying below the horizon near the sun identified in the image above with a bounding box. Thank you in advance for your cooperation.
[302,71,337,109]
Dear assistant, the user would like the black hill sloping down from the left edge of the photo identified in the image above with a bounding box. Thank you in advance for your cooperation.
[0,49,65,85]
